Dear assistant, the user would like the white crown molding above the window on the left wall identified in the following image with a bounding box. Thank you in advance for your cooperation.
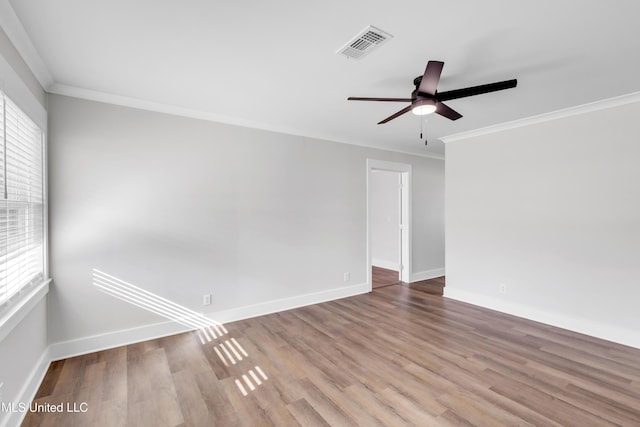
[0,0,54,91]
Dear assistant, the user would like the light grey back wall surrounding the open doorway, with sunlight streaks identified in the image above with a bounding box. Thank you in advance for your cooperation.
[49,95,444,357]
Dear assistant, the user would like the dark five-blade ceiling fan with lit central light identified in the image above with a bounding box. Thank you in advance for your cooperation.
[347,61,518,125]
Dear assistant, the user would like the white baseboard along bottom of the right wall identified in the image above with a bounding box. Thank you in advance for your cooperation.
[444,287,640,349]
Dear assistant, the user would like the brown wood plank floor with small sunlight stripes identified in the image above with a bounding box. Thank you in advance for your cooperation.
[23,284,640,427]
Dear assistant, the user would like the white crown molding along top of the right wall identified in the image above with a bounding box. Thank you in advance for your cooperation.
[440,92,640,144]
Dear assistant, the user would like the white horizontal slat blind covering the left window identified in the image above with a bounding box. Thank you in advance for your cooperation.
[0,92,44,307]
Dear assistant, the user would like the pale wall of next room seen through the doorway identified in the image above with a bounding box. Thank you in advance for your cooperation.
[369,170,400,271]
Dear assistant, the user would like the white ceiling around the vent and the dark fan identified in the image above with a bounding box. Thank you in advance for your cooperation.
[0,0,640,156]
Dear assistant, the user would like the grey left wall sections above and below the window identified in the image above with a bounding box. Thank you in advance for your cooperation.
[0,25,48,426]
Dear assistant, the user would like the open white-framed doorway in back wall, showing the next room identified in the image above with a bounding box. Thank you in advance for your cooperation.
[367,159,411,289]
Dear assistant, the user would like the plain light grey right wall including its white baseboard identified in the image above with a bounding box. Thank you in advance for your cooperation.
[445,98,640,347]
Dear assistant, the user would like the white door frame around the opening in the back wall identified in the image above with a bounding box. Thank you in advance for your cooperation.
[367,159,411,291]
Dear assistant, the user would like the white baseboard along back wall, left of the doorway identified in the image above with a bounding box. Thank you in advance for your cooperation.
[49,283,371,360]
